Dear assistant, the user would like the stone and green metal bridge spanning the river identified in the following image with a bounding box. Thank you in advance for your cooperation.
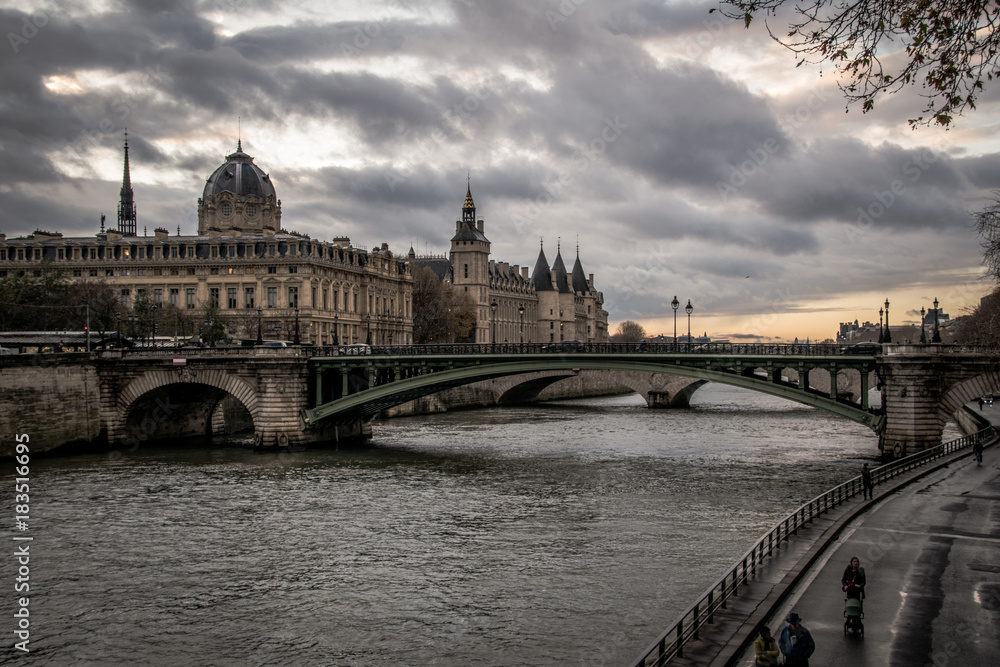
[0,345,1000,456]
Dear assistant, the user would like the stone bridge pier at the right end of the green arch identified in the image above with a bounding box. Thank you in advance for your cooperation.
[879,345,1000,457]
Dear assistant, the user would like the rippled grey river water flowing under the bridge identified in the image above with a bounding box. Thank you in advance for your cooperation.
[0,384,912,665]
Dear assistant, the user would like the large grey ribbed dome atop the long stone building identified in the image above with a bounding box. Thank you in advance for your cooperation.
[198,142,281,234]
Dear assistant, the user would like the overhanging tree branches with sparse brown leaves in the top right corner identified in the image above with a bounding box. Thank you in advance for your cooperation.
[709,0,1000,126]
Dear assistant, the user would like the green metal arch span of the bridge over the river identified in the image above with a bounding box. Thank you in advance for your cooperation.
[301,354,882,431]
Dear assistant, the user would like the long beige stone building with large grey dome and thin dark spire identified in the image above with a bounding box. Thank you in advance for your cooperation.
[0,137,413,345]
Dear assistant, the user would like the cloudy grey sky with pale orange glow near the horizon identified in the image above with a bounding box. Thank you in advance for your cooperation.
[0,0,1000,340]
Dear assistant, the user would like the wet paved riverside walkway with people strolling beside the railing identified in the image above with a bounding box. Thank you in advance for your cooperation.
[646,406,1000,667]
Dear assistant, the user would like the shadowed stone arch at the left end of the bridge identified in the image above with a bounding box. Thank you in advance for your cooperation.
[114,370,260,442]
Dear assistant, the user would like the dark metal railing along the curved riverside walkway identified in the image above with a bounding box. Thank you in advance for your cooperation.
[630,426,997,667]
